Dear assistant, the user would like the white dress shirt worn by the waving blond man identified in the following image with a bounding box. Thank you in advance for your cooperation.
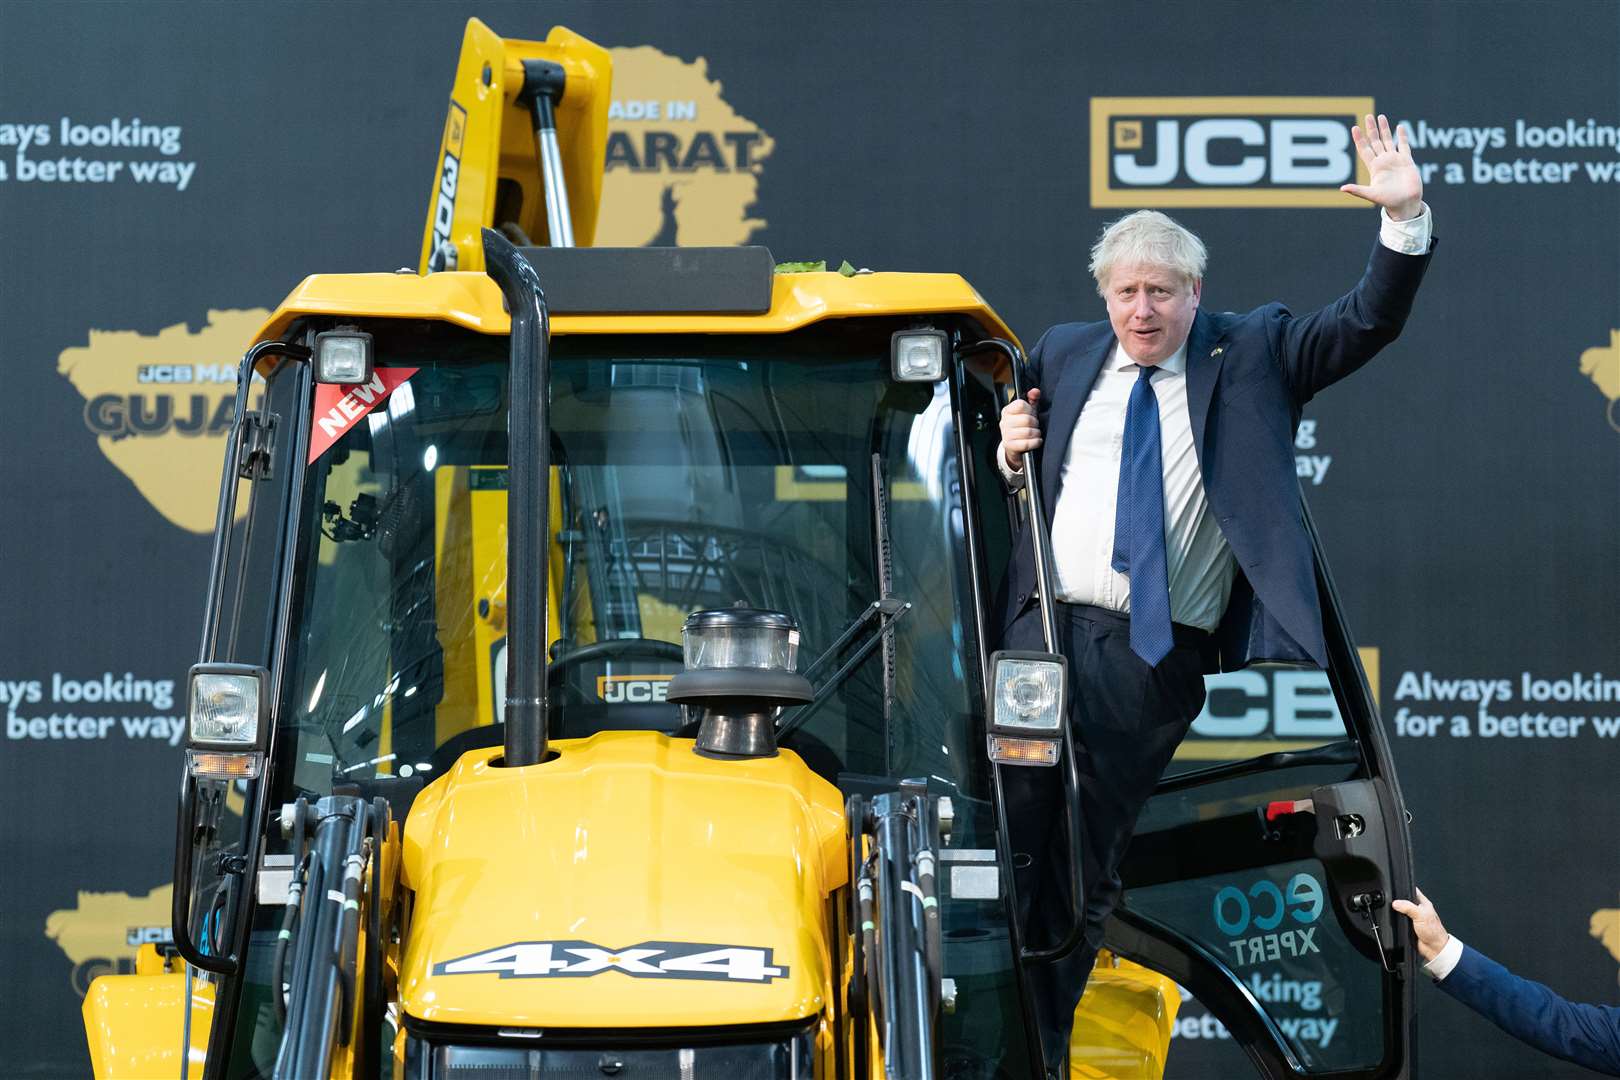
[996,204,1434,630]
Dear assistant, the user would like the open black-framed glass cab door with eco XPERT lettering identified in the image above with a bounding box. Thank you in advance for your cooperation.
[1106,510,1421,1080]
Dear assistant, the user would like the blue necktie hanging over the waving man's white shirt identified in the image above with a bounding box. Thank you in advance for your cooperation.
[1113,364,1175,667]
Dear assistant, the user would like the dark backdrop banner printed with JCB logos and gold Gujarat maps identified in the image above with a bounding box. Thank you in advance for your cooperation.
[0,0,1620,1078]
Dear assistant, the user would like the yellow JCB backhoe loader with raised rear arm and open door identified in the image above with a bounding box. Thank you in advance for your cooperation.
[84,19,1409,1080]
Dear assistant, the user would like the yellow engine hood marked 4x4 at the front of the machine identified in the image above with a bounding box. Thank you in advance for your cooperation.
[400,732,849,1028]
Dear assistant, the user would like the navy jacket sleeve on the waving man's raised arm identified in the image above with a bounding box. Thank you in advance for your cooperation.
[1264,240,1435,405]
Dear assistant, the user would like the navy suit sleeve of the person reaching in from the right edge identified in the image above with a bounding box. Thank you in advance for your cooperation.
[1439,946,1620,1077]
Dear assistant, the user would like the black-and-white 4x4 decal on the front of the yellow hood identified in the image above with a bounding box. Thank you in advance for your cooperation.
[433,941,787,983]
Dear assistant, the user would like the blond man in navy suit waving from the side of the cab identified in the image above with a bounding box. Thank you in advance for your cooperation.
[998,117,1432,1075]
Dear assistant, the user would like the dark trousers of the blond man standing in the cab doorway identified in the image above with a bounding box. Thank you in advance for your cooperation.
[1001,604,1207,1080]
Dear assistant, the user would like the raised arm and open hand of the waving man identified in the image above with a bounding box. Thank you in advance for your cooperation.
[1270,117,1434,403]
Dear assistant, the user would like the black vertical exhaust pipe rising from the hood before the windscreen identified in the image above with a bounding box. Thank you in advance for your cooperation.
[483,228,551,766]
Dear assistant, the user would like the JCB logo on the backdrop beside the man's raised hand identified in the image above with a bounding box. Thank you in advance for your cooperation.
[1092,97,1372,207]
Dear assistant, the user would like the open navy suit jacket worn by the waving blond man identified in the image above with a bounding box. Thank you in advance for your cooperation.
[1001,241,1435,670]
